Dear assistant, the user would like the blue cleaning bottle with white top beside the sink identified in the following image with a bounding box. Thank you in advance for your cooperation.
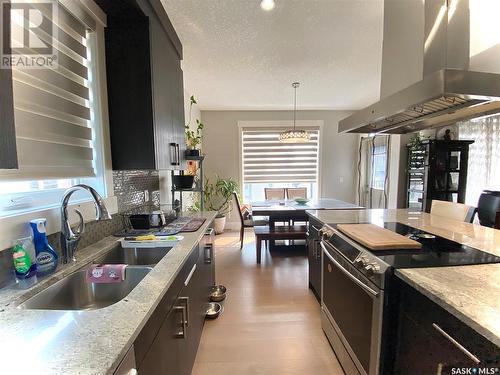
[30,219,58,276]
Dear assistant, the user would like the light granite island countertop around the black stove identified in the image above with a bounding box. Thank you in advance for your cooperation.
[308,209,500,346]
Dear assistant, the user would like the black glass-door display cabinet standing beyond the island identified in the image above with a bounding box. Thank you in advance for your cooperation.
[406,140,474,212]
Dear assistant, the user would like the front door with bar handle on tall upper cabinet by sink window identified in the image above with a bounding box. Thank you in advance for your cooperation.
[148,5,179,169]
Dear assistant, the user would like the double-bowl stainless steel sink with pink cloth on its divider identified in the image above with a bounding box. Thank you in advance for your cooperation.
[19,244,171,310]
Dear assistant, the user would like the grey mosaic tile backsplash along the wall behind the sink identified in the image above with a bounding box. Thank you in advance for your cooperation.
[0,170,160,287]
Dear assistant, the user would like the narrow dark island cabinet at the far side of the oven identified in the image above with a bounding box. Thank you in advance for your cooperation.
[307,217,322,301]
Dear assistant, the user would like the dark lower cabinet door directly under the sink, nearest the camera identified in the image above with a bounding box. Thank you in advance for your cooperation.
[138,304,187,375]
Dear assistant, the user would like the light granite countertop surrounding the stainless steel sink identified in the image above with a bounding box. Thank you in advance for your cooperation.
[0,212,215,375]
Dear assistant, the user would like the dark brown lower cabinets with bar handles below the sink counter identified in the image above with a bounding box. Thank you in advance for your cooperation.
[134,229,215,375]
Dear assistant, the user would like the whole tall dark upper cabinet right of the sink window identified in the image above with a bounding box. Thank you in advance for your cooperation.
[97,0,185,170]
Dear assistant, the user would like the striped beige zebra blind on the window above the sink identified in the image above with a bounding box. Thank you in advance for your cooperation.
[0,1,95,179]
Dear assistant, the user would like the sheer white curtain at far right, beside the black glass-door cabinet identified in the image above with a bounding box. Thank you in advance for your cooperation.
[458,115,500,206]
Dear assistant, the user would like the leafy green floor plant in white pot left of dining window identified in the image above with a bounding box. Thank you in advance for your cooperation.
[204,176,238,234]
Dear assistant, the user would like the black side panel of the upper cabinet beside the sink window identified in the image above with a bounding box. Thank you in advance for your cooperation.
[99,11,155,170]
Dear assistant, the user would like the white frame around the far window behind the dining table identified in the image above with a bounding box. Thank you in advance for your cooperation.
[238,120,324,201]
